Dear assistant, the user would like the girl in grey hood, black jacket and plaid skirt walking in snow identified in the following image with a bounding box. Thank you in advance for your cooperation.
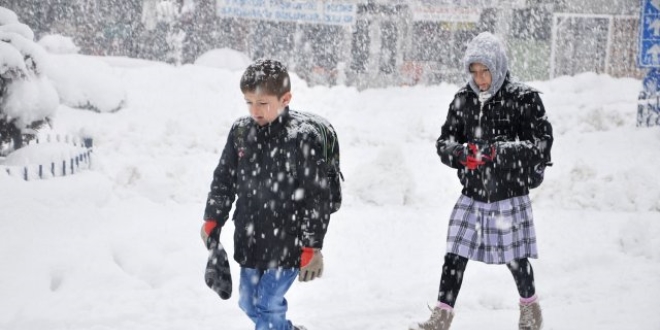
[411,32,553,330]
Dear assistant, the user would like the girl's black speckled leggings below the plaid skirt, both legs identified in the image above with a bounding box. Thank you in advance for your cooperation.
[438,253,536,307]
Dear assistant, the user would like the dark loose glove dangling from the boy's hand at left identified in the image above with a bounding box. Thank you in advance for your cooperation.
[204,241,232,300]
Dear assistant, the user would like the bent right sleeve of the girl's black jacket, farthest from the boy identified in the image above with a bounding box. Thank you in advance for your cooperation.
[496,92,554,169]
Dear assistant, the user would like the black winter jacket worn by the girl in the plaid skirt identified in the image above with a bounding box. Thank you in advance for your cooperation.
[436,77,553,202]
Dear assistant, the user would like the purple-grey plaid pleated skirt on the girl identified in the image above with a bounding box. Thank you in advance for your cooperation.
[447,195,538,264]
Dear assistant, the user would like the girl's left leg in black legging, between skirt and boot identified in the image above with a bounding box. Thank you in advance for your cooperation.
[438,253,468,308]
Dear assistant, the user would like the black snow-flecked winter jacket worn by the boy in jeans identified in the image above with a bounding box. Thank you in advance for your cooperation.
[204,108,330,269]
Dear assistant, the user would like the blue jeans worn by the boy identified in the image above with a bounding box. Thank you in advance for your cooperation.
[238,268,298,330]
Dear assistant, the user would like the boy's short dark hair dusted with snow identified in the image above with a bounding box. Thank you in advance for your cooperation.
[241,60,291,98]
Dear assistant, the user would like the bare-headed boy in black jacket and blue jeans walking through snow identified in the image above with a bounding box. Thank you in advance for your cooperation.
[202,60,330,330]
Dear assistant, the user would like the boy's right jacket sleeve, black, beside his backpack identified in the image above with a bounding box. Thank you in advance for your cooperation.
[296,130,330,248]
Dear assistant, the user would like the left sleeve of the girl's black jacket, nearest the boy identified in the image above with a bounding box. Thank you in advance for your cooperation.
[435,95,467,169]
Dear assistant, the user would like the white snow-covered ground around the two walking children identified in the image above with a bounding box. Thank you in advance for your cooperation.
[0,55,660,330]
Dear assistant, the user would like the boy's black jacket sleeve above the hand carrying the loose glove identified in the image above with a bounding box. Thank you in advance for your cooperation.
[204,125,238,226]
